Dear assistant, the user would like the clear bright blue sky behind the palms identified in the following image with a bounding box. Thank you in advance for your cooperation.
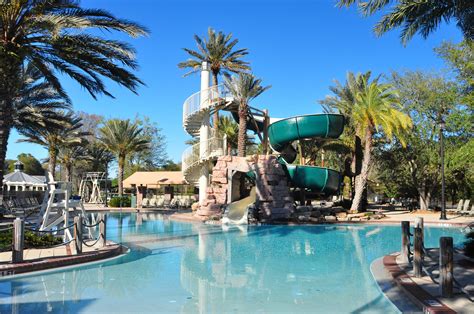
[7,0,461,161]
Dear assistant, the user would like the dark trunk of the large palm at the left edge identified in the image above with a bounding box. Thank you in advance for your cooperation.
[0,52,21,191]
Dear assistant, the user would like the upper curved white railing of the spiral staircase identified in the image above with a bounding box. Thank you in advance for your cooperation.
[183,84,231,130]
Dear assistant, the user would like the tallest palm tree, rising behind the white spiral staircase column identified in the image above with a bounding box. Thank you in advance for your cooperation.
[178,27,250,129]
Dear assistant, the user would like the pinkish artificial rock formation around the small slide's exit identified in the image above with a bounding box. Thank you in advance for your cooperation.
[197,155,294,221]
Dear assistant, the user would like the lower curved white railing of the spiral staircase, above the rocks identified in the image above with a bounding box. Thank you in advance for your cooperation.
[181,135,227,181]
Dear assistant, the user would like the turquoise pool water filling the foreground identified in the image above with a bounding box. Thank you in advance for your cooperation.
[0,214,463,313]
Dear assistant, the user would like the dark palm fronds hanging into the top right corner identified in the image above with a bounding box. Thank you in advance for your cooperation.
[338,0,474,44]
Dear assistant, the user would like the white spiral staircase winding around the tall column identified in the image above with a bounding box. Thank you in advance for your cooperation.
[181,84,233,185]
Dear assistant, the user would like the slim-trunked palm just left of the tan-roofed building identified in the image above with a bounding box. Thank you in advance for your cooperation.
[100,119,150,196]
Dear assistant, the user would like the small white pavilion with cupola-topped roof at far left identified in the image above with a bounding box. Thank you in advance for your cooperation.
[3,161,47,191]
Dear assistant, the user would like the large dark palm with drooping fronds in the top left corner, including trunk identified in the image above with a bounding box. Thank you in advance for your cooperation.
[0,0,147,190]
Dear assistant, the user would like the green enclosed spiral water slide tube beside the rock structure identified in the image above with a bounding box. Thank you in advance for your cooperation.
[268,114,344,195]
